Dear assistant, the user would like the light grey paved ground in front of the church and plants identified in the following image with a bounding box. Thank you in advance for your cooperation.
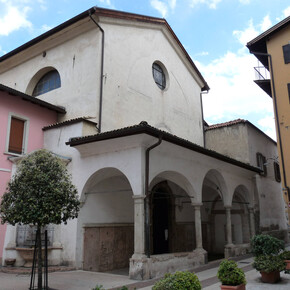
[0,258,290,290]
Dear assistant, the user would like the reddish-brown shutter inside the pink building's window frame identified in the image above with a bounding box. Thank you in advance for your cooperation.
[8,117,25,154]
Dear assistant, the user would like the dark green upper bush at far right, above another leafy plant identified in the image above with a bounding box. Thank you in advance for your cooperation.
[251,235,285,256]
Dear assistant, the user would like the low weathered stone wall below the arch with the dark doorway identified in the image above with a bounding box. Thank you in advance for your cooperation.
[129,249,207,280]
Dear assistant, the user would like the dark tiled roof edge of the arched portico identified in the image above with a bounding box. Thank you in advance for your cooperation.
[66,121,261,173]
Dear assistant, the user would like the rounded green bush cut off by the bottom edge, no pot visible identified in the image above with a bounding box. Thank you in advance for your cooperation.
[152,271,201,290]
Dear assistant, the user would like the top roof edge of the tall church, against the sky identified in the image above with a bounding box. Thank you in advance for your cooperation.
[0,7,209,91]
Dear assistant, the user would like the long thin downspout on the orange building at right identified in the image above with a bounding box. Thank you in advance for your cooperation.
[250,51,290,199]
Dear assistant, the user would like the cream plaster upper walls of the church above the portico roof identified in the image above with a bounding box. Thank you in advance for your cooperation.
[0,19,203,145]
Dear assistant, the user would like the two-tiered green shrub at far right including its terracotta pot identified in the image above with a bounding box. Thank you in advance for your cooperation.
[251,235,285,283]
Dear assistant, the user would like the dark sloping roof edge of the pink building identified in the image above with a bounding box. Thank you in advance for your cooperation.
[0,84,66,114]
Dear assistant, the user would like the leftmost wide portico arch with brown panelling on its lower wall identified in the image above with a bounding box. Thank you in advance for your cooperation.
[78,168,134,272]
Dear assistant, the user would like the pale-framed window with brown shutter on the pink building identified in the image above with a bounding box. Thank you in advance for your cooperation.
[7,116,28,154]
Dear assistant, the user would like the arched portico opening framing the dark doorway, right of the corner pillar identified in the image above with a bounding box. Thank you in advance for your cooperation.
[149,171,196,255]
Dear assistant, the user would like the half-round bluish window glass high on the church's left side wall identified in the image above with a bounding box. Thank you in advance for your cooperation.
[32,70,61,97]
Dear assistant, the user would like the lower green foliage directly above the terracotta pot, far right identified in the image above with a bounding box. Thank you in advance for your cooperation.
[253,255,286,273]
